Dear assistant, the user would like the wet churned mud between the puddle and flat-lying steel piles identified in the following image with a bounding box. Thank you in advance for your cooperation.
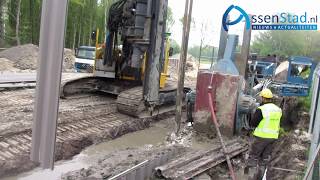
[62,119,226,180]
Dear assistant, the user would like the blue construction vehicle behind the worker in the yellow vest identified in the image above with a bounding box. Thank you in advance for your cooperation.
[248,56,316,97]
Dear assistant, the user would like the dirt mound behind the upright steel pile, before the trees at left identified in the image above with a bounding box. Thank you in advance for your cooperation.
[0,44,75,72]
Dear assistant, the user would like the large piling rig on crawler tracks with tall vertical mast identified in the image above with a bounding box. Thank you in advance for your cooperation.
[61,0,185,117]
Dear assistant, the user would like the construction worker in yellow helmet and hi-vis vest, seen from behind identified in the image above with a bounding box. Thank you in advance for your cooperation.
[245,89,282,179]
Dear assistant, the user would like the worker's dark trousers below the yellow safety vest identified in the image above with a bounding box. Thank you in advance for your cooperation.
[247,136,276,167]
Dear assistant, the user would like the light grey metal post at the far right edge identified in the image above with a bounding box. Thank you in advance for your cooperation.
[308,69,320,180]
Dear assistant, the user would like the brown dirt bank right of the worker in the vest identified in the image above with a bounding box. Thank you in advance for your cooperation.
[270,112,311,180]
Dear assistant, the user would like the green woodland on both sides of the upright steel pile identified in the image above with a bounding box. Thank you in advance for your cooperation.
[0,0,114,48]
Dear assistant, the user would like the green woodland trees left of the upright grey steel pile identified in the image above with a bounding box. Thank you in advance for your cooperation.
[0,0,41,47]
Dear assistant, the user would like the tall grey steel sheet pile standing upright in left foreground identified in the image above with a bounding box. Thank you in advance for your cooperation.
[30,0,68,169]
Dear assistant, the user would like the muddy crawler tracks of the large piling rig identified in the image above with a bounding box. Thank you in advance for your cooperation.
[60,76,190,118]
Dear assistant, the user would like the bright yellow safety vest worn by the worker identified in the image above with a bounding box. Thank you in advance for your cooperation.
[253,103,282,139]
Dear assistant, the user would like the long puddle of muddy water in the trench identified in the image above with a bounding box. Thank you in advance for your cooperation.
[3,119,212,180]
